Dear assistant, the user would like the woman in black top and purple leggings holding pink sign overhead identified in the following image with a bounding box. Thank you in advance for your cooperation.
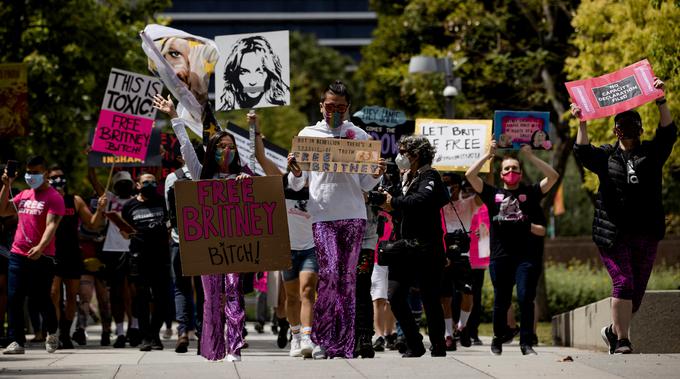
[571,79,678,354]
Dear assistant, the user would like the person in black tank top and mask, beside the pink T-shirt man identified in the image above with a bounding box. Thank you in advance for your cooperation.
[48,166,110,349]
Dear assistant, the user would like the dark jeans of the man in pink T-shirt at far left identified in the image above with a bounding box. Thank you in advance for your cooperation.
[7,253,57,346]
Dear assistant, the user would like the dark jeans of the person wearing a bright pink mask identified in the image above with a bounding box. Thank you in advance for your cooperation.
[489,257,542,345]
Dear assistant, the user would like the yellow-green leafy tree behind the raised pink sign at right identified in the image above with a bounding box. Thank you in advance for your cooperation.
[566,0,680,233]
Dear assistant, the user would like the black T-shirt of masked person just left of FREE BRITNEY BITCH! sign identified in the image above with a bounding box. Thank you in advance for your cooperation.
[121,196,169,261]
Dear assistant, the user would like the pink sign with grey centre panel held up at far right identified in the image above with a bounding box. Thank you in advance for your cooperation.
[565,59,664,121]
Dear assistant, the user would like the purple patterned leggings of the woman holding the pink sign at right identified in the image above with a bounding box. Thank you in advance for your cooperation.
[600,233,659,313]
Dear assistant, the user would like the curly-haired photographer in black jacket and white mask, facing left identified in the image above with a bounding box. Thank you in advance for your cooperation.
[382,136,449,358]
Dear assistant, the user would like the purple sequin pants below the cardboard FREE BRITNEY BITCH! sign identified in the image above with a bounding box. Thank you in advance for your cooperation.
[201,274,246,361]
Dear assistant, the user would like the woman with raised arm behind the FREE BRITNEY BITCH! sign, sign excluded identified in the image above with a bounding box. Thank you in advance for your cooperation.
[153,95,251,362]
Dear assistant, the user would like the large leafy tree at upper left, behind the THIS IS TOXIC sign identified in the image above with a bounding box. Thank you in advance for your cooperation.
[0,0,170,190]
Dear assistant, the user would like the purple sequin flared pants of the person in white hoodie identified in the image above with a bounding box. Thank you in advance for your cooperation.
[312,219,366,358]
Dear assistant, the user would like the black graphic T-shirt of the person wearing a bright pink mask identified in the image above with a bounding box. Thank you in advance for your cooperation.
[479,183,543,259]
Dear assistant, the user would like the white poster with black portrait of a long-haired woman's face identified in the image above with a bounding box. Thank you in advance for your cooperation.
[215,30,290,111]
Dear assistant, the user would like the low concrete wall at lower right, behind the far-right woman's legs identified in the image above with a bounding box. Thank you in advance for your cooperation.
[552,291,680,354]
